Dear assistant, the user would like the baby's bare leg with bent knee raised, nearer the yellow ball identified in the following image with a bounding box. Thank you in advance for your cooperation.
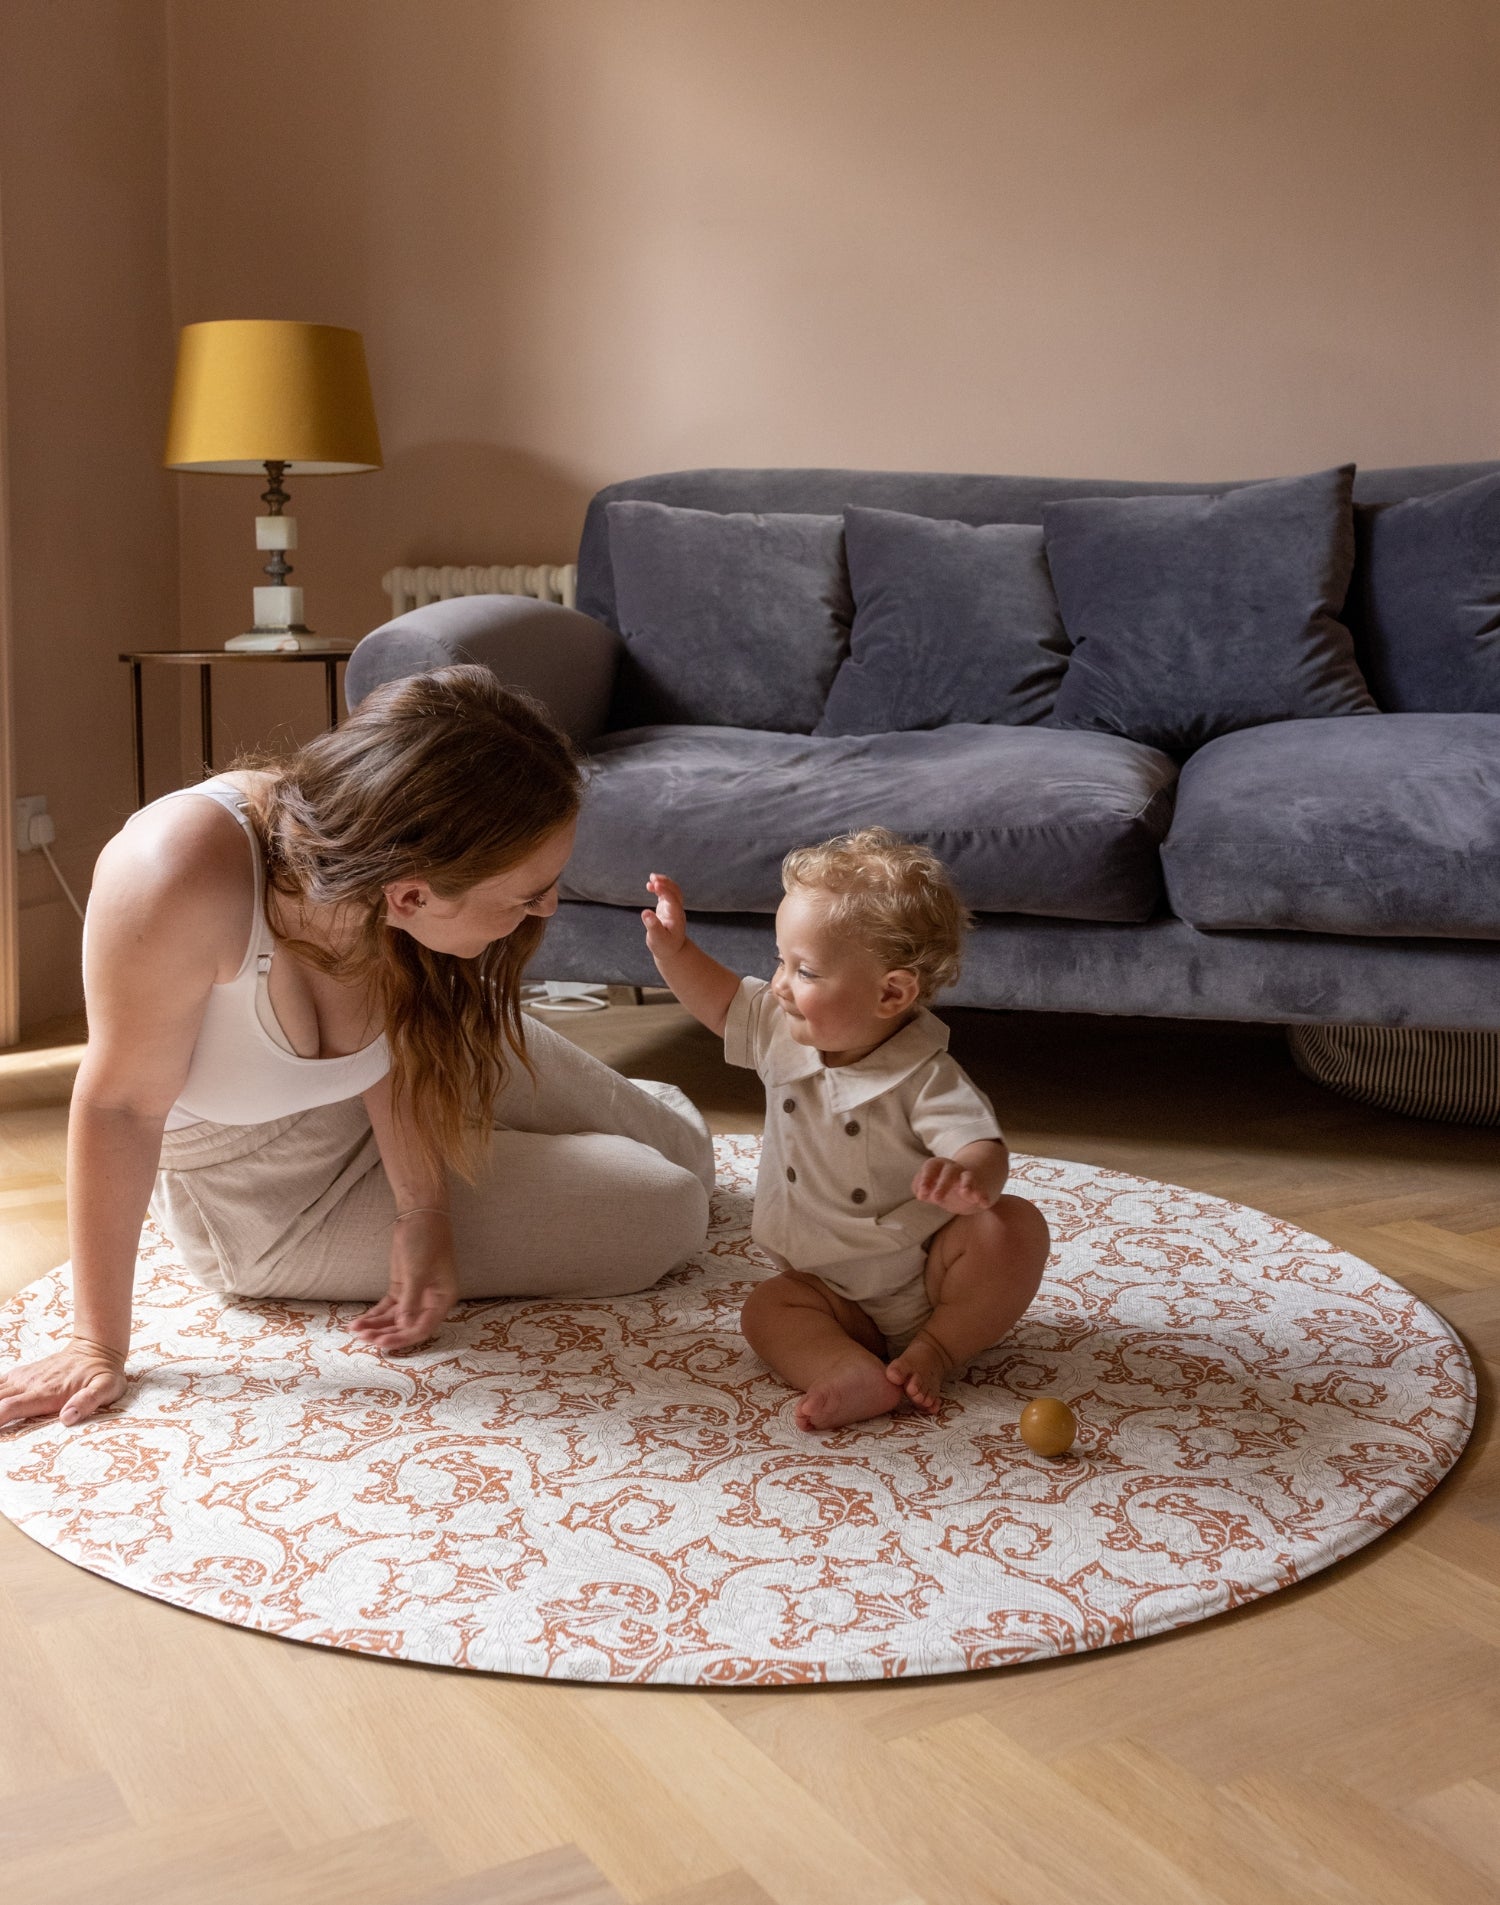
[886,1194,1052,1414]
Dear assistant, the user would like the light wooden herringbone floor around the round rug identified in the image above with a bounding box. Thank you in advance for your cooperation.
[0,994,1500,1905]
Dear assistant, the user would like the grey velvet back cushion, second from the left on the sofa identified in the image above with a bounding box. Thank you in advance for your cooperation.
[814,509,1067,733]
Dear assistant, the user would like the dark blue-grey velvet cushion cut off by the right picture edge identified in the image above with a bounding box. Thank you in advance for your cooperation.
[1349,476,1500,714]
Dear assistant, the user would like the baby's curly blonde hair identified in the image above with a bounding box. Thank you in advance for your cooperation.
[781,827,974,1004]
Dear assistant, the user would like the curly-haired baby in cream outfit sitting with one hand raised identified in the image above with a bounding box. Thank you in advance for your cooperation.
[640,827,1048,1429]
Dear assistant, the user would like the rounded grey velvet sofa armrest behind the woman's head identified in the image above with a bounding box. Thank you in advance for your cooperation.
[343,596,623,747]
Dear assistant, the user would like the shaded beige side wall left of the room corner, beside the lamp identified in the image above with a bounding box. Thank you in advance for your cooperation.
[0,0,177,1029]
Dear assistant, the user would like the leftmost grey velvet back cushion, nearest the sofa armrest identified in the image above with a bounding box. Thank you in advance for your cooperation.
[608,503,854,733]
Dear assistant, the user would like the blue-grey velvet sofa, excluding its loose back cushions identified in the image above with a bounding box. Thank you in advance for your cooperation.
[347,463,1500,1029]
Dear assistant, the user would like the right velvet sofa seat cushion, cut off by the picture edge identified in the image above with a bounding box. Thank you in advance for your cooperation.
[1161,714,1500,939]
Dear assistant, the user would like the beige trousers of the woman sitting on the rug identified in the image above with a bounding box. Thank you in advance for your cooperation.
[151,1017,713,1301]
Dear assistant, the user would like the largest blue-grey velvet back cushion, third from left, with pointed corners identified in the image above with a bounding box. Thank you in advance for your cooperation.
[1043,465,1374,754]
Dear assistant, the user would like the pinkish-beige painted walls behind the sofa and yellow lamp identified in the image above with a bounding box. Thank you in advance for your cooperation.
[0,0,1500,1010]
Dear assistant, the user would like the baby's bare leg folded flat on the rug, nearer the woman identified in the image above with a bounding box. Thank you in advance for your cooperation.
[740,1271,903,1429]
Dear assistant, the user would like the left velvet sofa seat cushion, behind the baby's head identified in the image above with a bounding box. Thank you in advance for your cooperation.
[562,722,1176,920]
